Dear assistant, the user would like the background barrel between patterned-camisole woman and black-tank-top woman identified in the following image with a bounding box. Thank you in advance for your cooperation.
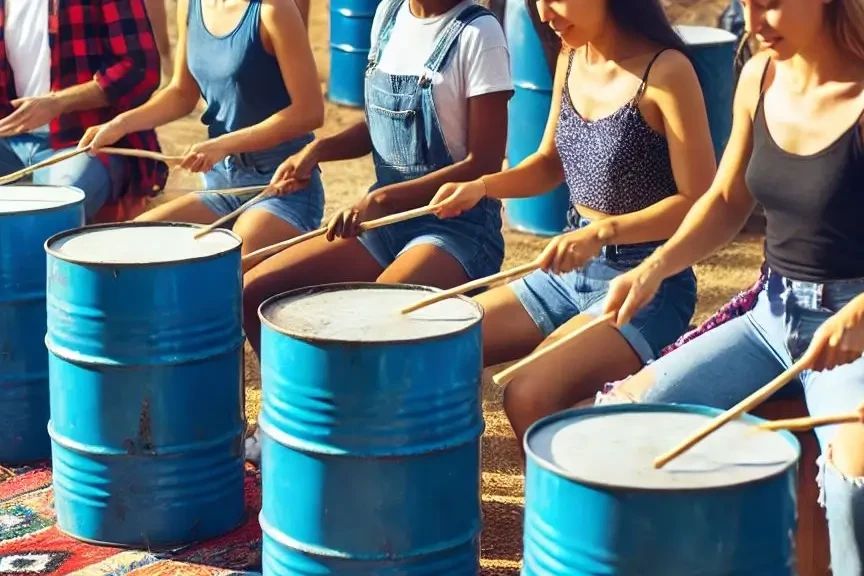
[676,26,738,160]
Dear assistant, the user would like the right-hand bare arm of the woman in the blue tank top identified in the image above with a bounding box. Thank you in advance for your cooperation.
[211,0,324,153]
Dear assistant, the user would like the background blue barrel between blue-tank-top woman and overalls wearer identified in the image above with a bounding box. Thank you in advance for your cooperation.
[327,0,378,107]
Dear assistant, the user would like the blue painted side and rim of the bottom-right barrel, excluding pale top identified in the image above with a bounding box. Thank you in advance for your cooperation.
[522,404,800,576]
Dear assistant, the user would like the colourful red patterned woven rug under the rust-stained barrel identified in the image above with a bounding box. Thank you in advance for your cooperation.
[0,466,261,576]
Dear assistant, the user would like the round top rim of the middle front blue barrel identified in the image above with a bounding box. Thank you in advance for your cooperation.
[258,282,485,346]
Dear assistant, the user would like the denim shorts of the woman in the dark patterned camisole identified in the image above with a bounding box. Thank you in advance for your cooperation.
[509,221,696,364]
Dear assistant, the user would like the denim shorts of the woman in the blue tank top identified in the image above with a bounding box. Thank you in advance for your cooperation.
[198,148,324,232]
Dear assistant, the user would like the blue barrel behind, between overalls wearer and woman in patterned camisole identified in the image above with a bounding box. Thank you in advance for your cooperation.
[504,0,570,236]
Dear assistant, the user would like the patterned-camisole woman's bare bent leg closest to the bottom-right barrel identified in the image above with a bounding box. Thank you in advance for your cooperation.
[504,314,642,457]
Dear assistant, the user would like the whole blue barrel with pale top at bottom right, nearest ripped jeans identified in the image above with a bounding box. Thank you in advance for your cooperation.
[522,404,801,576]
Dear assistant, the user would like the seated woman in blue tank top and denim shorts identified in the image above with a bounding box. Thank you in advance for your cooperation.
[80,0,324,253]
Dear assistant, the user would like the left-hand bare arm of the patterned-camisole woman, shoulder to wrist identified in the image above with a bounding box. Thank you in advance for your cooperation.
[480,51,569,198]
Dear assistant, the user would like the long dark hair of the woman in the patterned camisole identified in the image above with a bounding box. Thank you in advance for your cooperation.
[526,0,688,74]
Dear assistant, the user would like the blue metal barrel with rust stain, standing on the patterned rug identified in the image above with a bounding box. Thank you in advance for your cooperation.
[45,223,245,549]
